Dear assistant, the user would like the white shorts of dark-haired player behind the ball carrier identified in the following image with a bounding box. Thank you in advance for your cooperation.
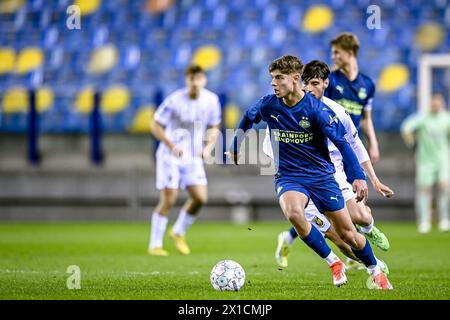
[305,165,356,235]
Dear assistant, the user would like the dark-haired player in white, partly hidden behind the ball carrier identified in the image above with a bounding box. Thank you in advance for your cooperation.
[270,60,393,288]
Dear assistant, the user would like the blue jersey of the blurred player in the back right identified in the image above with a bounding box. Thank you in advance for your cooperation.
[325,70,375,130]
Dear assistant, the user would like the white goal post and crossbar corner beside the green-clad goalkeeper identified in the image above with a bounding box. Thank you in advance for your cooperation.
[417,54,450,112]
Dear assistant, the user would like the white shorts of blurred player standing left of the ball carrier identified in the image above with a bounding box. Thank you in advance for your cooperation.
[156,154,208,190]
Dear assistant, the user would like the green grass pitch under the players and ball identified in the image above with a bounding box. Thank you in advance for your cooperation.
[0,221,450,300]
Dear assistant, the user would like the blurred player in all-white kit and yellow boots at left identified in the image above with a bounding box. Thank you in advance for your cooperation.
[148,65,221,256]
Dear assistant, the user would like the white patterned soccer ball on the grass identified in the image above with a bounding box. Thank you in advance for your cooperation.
[210,260,245,291]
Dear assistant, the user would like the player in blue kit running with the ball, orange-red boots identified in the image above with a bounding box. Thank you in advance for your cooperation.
[228,56,392,289]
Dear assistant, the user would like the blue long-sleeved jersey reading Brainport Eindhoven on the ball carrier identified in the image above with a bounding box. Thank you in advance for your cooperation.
[231,94,365,181]
